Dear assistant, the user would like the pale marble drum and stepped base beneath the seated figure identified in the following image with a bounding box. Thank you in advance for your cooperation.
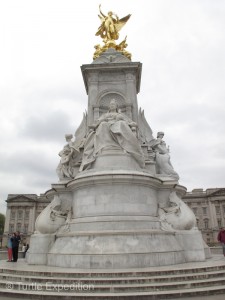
[28,158,205,269]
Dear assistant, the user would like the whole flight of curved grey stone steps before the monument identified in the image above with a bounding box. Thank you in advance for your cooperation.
[0,260,225,300]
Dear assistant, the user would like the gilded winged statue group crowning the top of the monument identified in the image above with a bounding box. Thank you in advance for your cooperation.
[93,4,131,59]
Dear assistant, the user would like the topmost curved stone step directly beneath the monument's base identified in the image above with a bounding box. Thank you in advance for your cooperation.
[0,255,225,279]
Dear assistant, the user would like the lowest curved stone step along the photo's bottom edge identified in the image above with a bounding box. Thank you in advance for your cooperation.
[0,284,225,300]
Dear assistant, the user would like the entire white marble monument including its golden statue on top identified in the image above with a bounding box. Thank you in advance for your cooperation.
[27,4,208,269]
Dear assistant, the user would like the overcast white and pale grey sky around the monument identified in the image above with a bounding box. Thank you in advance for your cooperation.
[0,0,225,213]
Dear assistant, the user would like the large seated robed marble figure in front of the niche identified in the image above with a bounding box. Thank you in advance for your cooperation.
[80,99,145,171]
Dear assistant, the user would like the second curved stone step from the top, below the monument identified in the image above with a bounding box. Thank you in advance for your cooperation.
[0,270,225,284]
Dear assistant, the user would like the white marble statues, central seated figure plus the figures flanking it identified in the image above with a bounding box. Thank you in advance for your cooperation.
[57,99,179,180]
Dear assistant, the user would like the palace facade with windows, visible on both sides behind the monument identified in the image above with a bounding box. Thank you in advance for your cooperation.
[2,188,225,246]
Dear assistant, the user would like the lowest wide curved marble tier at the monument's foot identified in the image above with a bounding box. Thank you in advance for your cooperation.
[48,230,185,269]
